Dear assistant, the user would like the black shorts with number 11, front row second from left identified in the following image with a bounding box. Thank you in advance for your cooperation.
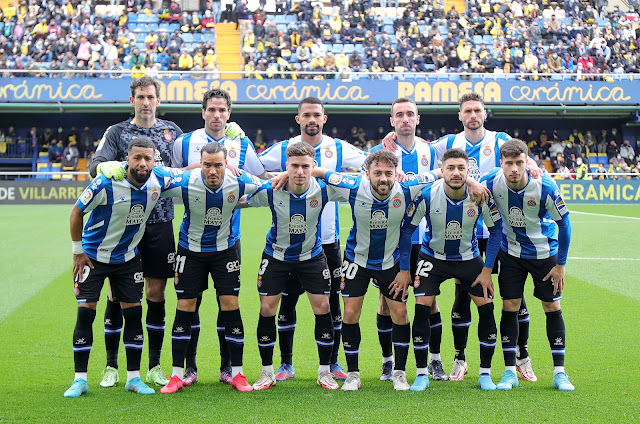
[173,246,240,299]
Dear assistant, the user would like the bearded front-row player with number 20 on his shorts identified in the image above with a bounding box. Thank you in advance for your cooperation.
[314,150,436,391]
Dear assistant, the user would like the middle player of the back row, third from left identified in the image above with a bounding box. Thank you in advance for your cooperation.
[260,97,366,381]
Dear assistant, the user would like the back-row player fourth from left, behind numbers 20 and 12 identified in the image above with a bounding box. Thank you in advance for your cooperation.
[371,98,447,381]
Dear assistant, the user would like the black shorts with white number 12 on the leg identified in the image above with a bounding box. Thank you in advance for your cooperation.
[413,252,484,297]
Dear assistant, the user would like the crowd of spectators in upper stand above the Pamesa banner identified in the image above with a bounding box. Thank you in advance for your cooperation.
[0,0,640,80]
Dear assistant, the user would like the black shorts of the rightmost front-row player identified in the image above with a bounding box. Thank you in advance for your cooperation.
[498,250,562,302]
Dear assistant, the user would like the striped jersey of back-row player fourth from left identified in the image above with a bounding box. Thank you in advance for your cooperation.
[370,140,438,244]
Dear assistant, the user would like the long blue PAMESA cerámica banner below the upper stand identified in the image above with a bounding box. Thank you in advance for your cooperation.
[0,79,640,106]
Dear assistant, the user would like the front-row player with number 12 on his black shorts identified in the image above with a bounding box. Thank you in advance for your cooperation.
[400,149,501,391]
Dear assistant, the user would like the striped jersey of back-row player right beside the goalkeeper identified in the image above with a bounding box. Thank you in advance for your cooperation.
[171,128,264,243]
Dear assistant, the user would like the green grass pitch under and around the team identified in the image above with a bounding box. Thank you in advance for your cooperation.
[0,205,640,423]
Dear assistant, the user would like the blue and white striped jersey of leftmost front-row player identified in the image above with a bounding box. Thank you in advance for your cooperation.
[76,167,179,264]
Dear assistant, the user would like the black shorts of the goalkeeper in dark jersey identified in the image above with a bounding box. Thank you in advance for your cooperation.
[138,221,176,278]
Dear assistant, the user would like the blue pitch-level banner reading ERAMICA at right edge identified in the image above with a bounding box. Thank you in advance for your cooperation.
[556,180,640,205]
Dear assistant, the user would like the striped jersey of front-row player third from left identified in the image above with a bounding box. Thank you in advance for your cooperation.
[248,178,337,262]
